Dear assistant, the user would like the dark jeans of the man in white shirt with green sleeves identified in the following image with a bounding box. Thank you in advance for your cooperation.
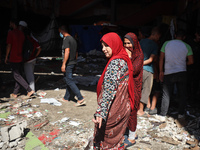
[160,72,187,116]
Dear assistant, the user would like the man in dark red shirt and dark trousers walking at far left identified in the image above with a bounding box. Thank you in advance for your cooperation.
[5,19,34,98]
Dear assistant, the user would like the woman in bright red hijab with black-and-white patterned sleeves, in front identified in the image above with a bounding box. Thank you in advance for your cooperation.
[93,32,134,149]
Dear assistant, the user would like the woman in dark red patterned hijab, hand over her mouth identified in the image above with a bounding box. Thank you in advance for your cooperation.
[124,32,144,147]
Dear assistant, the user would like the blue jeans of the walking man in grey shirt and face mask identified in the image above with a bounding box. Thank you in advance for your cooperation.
[64,65,83,100]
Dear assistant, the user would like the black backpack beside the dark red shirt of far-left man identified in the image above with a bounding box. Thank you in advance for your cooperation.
[22,36,34,61]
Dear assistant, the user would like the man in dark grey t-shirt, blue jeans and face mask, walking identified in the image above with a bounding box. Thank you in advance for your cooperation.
[59,25,85,106]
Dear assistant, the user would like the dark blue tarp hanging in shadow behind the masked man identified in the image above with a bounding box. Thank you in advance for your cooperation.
[70,25,102,53]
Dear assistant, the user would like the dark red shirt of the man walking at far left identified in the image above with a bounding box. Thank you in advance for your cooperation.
[7,29,25,63]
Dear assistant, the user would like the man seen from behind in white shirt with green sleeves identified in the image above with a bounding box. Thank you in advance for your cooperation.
[157,30,193,121]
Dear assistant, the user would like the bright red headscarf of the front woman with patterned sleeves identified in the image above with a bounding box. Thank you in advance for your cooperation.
[97,32,134,109]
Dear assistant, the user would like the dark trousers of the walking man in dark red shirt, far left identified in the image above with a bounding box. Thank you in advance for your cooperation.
[10,63,32,94]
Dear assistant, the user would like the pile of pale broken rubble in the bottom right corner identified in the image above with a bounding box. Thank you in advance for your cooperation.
[129,115,200,150]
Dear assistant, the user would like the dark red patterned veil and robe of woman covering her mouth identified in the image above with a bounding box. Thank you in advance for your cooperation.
[125,33,144,132]
